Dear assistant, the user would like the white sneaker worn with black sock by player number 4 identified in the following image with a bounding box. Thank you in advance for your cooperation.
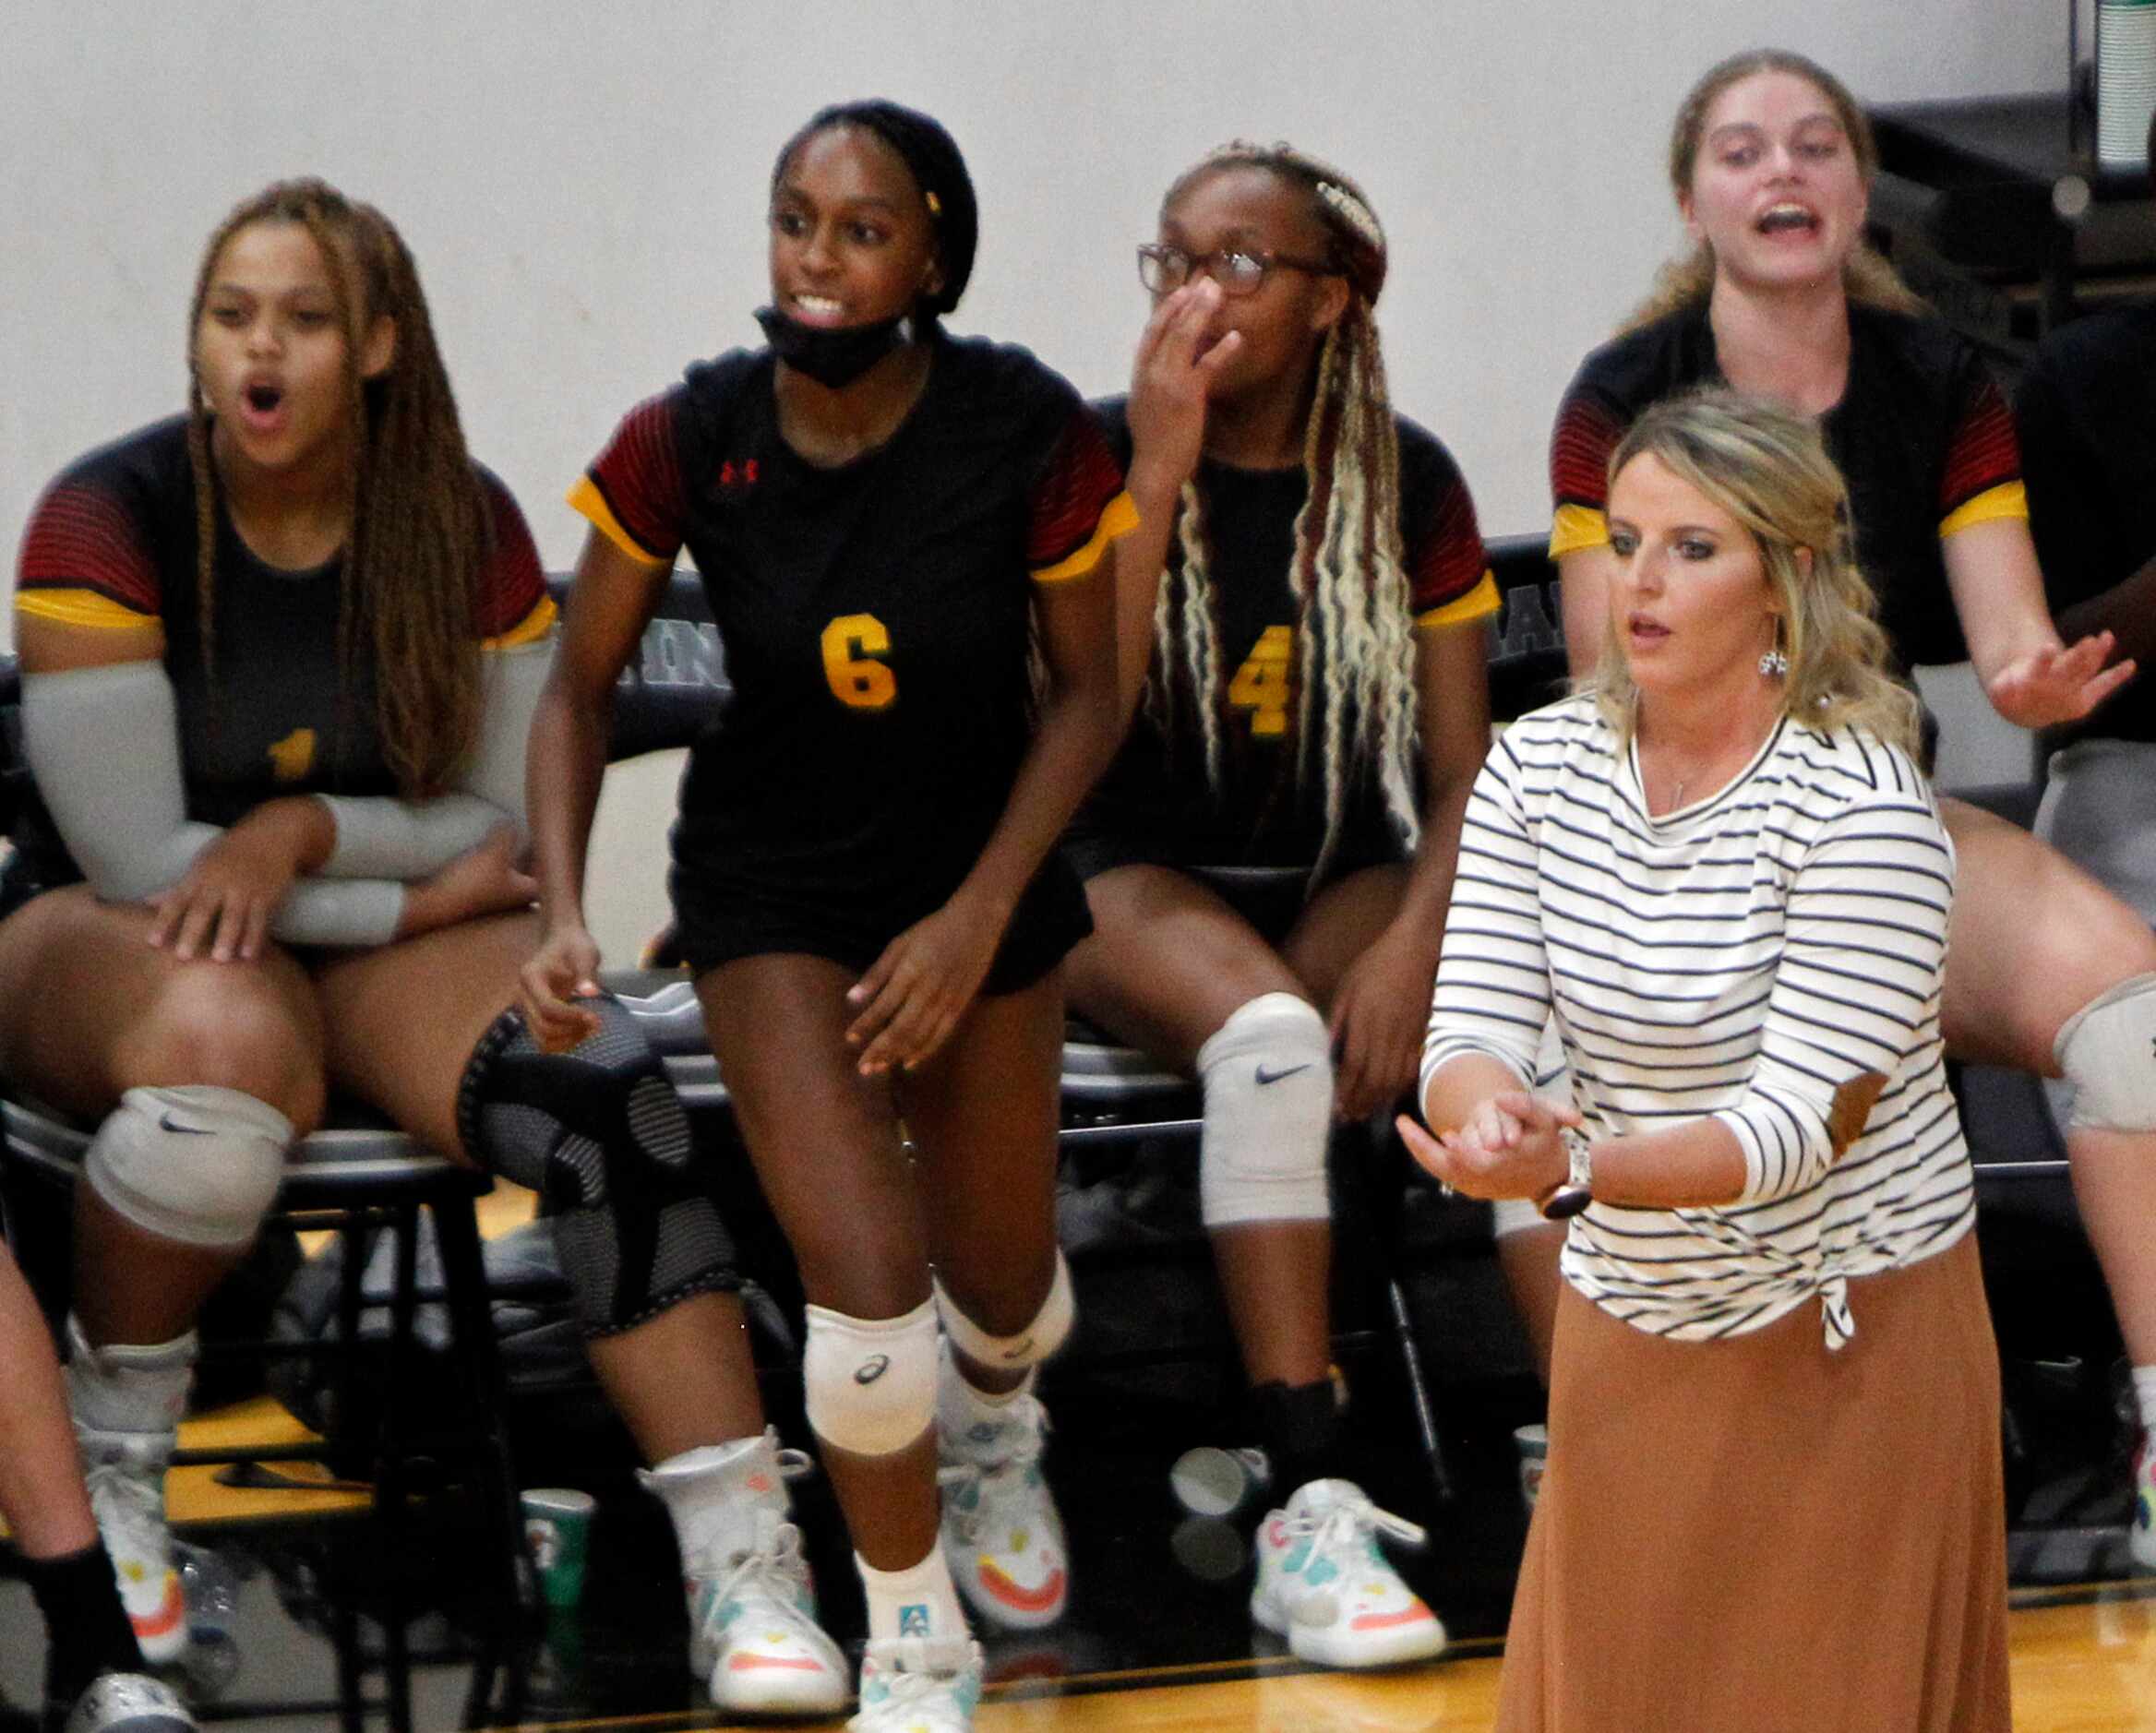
[1251,1481,1444,1667]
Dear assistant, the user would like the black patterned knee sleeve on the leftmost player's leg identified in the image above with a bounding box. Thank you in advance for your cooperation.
[457,994,739,1336]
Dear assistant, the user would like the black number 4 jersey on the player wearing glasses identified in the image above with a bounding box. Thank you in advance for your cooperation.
[1078,397,1499,866]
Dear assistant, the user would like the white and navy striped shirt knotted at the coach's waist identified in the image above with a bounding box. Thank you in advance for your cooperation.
[1423,696,1975,1347]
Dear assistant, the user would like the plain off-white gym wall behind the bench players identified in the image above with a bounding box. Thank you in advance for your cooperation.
[0,0,2066,962]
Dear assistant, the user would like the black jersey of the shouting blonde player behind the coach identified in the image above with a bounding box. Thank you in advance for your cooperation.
[1551,302,2029,666]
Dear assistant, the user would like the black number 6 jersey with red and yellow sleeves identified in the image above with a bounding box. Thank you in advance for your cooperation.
[569,334,1136,923]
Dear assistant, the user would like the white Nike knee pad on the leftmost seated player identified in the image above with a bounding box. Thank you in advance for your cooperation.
[82,1084,291,1250]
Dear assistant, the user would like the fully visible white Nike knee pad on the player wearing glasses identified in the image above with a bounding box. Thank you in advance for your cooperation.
[1199,994,1333,1226]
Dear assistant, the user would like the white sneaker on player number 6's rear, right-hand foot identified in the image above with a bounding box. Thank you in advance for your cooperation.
[938,1394,1070,1630]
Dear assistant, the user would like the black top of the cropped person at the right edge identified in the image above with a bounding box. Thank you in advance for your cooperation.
[2014,302,2156,739]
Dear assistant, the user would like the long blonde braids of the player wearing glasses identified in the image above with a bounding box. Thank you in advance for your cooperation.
[1144,140,1420,881]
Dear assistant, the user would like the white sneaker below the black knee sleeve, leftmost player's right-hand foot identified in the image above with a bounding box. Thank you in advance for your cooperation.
[688,1511,847,1715]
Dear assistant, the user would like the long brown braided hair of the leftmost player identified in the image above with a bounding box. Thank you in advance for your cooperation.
[187,179,492,797]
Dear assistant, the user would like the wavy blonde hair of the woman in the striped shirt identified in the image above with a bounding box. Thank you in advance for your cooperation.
[1587,386,1917,755]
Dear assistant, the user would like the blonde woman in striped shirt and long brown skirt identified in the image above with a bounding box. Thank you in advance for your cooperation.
[1401,392,2007,1733]
